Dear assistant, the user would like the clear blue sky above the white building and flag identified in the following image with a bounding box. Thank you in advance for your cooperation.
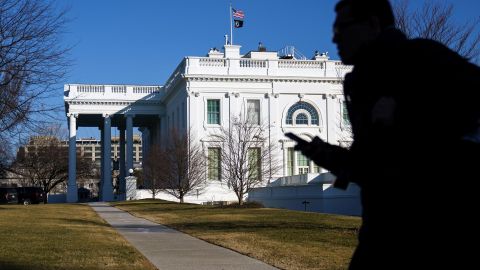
[52,0,480,137]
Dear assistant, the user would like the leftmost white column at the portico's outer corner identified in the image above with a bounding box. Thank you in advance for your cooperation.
[67,113,78,203]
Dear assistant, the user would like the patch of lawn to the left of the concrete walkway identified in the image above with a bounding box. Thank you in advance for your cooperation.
[0,204,156,270]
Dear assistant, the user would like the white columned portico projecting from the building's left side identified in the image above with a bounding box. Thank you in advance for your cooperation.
[64,84,162,202]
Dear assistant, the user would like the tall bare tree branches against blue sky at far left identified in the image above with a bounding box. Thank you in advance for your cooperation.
[0,0,69,142]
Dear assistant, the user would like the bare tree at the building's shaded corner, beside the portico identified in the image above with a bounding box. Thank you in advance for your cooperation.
[145,129,206,203]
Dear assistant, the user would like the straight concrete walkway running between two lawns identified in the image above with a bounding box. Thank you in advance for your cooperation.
[89,202,277,270]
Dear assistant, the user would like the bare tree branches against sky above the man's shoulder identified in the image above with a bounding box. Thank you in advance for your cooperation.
[392,0,480,62]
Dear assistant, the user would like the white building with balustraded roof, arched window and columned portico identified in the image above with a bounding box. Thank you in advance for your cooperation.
[65,42,351,202]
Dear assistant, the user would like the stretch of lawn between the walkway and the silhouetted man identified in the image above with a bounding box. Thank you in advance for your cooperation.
[114,200,361,269]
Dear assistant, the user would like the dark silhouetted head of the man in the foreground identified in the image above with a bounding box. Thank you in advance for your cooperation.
[333,0,395,65]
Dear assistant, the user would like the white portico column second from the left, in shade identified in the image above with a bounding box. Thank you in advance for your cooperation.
[102,114,113,201]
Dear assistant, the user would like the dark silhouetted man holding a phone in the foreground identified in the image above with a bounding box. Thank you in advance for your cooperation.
[288,0,480,269]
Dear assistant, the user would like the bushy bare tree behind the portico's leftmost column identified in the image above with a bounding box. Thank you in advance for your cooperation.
[9,126,95,203]
